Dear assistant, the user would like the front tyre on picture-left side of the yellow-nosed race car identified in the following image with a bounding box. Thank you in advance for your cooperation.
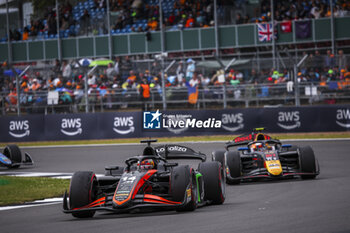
[225,151,242,184]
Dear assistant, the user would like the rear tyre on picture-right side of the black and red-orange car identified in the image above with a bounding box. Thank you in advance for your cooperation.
[198,161,226,205]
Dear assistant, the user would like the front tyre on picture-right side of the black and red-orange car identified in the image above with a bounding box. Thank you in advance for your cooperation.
[170,165,198,211]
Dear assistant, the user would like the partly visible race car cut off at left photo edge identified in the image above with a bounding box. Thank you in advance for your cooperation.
[0,144,34,169]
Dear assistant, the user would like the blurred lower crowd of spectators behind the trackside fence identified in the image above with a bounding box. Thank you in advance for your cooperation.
[0,50,350,110]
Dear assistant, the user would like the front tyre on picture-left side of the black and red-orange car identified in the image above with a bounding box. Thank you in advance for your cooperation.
[69,171,98,218]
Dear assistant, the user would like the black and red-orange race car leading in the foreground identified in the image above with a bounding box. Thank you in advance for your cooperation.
[63,140,225,218]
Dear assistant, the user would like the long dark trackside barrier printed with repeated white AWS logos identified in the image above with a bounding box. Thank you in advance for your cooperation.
[0,105,350,142]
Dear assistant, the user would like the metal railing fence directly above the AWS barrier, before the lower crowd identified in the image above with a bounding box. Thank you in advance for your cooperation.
[0,81,350,115]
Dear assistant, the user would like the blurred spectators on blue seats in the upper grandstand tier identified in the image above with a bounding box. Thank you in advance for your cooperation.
[2,0,350,41]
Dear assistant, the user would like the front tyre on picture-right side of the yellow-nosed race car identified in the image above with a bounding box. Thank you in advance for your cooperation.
[299,146,316,179]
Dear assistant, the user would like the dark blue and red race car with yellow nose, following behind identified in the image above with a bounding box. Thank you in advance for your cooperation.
[212,128,320,184]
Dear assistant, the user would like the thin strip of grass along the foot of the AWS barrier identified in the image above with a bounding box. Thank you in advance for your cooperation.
[0,132,350,147]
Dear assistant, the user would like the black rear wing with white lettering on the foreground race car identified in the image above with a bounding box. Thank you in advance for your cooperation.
[154,144,207,162]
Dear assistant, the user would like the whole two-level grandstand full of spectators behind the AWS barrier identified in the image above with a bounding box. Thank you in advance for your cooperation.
[0,0,350,115]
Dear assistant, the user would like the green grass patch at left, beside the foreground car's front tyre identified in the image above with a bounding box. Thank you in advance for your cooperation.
[0,176,70,206]
